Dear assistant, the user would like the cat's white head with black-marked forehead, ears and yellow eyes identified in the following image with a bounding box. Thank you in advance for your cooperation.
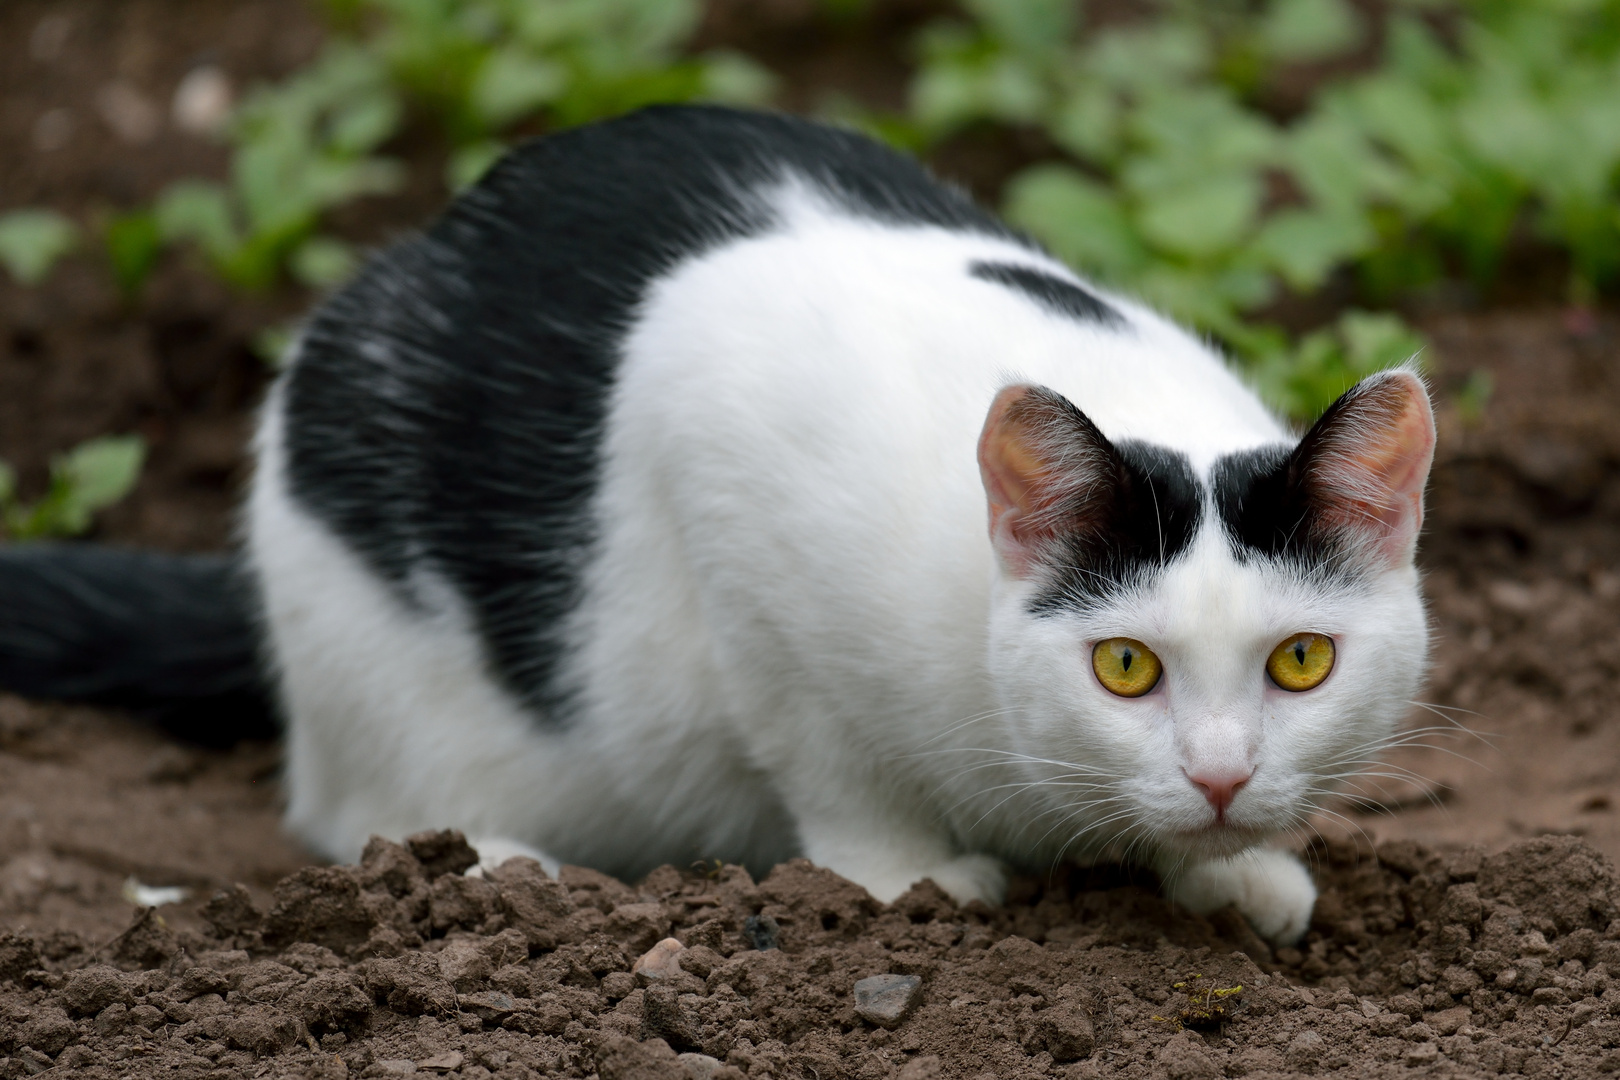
[978,371,1434,858]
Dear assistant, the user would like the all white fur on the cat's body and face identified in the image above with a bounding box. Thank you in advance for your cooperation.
[249,183,1426,941]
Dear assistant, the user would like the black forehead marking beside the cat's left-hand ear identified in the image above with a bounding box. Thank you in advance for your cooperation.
[1030,442,1204,615]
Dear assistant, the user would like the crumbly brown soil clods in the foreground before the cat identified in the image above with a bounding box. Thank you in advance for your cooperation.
[0,839,1620,1080]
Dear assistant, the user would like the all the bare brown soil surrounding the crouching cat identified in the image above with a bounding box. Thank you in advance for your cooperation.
[0,0,1620,1080]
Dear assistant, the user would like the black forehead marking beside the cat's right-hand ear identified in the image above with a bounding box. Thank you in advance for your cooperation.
[1210,444,1340,568]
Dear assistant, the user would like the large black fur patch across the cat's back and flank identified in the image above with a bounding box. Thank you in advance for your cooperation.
[284,107,1024,719]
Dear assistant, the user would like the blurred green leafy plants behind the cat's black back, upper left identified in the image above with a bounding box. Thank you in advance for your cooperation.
[105,0,771,293]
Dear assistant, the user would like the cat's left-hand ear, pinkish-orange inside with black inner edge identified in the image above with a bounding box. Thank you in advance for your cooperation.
[978,385,1121,576]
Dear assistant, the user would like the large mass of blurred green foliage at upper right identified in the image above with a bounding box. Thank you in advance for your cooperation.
[889,0,1620,418]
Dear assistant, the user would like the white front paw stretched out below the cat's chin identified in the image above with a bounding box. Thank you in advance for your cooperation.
[1158,847,1315,946]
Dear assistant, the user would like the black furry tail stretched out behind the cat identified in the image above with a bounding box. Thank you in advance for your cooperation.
[0,544,275,746]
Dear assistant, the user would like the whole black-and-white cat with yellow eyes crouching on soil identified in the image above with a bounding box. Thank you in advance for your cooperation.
[0,107,1434,944]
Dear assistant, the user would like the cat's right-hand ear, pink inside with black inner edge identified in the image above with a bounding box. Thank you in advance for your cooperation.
[1290,369,1434,565]
